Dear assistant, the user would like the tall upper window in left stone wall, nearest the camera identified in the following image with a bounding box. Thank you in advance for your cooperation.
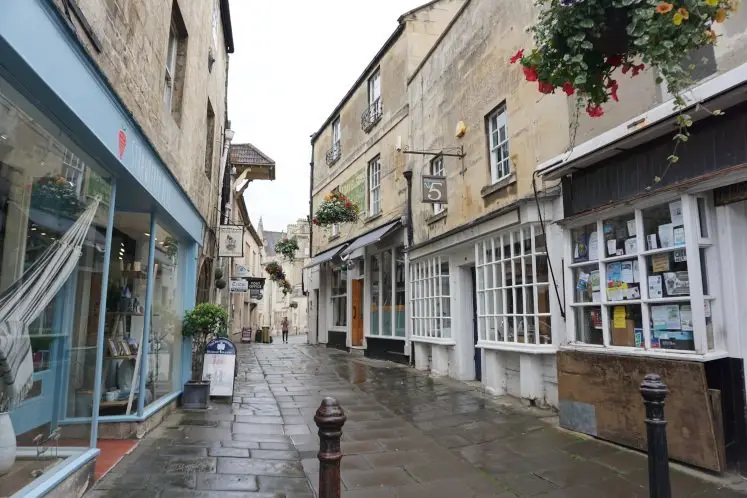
[163,1,187,122]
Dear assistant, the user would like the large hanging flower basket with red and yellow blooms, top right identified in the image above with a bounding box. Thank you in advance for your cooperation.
[510,0,738,117]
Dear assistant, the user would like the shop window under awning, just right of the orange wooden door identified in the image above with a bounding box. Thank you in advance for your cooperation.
[367,247,405,338]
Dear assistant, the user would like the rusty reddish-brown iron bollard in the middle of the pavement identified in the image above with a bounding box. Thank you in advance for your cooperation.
[314,398,347,498]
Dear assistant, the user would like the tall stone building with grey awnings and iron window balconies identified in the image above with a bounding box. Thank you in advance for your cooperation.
[307,0,463,359]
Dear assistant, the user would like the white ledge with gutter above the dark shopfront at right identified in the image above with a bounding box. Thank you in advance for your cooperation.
[536,63,747,180]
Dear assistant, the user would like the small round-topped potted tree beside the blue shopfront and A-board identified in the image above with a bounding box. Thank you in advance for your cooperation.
[182,303,228,409]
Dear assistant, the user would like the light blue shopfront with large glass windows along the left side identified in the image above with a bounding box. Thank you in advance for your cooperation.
[0,0,204,496]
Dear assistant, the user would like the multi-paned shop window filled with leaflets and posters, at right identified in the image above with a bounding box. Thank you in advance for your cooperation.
[569,196,714,352]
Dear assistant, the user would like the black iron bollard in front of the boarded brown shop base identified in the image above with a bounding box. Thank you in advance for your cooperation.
[641,374,672,498]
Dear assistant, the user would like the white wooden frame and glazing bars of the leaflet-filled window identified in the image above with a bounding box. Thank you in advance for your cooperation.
[564,194,725,359]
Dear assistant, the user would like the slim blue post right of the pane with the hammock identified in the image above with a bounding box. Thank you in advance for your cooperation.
[91,178,117,448]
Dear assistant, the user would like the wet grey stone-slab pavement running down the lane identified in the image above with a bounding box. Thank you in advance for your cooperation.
[86,336,747,498]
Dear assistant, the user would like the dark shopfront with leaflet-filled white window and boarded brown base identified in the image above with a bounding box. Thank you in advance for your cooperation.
[538,65,747,472]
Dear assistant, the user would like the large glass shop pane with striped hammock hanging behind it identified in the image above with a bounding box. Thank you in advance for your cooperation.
[0,79,111,496]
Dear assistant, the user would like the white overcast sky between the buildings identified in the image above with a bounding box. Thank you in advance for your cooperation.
[228,0,425,231]
